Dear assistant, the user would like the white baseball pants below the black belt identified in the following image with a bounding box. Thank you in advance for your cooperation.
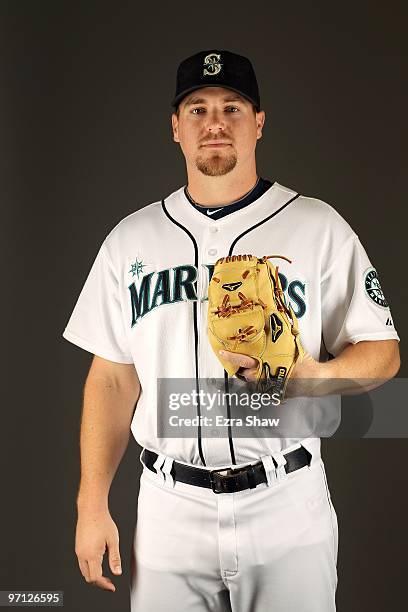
[130,448,338,612]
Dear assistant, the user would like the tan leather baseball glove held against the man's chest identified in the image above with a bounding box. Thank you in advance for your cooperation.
[208,255,304,400]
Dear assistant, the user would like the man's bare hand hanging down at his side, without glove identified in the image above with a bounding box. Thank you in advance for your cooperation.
[75,509,122,592]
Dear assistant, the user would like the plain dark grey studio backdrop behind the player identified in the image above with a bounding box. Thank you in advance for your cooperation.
[0,0,408,612]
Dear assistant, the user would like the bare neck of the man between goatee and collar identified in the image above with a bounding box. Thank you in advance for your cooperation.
[187,163,258,207]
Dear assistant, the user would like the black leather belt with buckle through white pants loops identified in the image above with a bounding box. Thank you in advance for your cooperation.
[142,446,312,493]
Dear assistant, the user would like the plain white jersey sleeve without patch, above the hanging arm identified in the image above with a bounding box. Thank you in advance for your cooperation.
[62,241,133,363]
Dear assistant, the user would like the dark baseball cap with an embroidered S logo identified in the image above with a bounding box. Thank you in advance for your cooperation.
[171,50,261,112]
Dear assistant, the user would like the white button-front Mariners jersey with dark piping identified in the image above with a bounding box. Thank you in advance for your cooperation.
[63,182,399,467]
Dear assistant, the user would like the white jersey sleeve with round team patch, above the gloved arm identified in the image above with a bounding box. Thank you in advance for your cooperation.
[321,233,399,357]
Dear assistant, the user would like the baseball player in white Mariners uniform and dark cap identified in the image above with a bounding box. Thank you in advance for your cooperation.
[63,50,399,612]
